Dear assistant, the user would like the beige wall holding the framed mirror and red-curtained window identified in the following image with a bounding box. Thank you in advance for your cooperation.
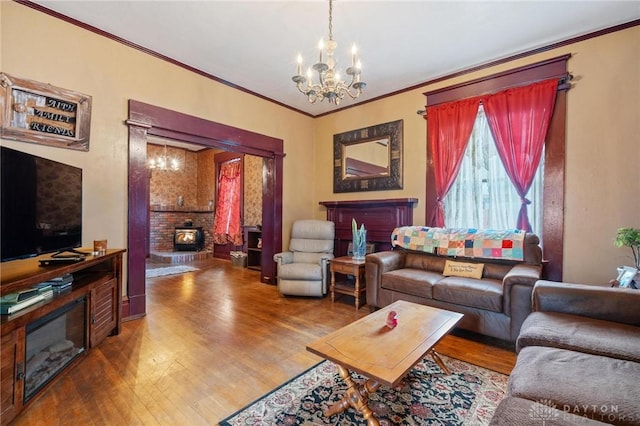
[314,26,640,284]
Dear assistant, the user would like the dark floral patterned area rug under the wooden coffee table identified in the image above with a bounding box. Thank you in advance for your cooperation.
[220,356,508,426]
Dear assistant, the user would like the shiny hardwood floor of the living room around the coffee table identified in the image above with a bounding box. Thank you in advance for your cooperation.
[14,259,515,425]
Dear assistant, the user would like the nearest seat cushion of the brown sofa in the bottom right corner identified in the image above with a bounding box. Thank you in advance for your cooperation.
[508,346,640,425]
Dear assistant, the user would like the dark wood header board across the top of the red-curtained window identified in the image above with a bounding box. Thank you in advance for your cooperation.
[423,55,571,106]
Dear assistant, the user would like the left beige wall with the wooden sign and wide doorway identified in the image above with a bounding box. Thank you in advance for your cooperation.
[0,1,315,280]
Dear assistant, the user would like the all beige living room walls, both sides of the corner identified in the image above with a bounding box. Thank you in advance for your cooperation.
[0,1,640,283]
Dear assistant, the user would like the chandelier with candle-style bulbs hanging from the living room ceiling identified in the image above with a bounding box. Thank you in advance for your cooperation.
[291,0,367,105]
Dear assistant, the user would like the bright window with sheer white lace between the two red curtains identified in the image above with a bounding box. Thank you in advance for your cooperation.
[444,106,544,239]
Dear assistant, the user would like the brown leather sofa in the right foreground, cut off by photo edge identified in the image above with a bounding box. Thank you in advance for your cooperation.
[491,281,640,426]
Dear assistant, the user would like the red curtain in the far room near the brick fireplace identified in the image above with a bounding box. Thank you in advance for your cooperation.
[213,160,242,246]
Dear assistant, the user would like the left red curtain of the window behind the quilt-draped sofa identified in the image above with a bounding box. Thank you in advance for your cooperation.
[427,98,480,227]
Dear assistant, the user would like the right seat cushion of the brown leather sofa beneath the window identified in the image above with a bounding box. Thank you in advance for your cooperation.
[433,277,502,312]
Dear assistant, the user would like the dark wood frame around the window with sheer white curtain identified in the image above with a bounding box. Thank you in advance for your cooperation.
[424,54,571,281]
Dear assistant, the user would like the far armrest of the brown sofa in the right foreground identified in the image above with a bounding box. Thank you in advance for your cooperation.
[533,280,640,326]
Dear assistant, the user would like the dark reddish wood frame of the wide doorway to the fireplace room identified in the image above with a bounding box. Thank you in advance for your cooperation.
[122,99,284,318]
